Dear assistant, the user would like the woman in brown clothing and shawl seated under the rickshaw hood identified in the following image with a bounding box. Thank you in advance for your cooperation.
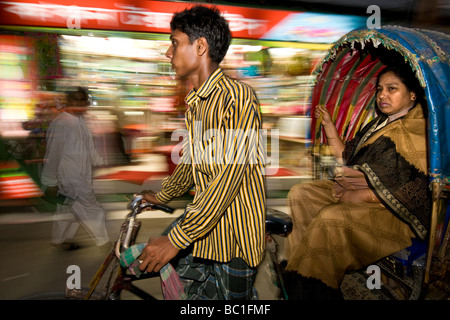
[285,60,431,299]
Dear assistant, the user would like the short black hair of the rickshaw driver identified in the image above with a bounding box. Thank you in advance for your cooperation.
[170,5,231,63]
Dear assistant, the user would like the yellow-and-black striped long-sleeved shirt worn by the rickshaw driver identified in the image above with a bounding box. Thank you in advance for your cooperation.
[156,68,266,267]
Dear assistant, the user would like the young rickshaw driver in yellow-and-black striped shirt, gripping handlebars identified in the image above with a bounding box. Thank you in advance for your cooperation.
[135,6,265,299]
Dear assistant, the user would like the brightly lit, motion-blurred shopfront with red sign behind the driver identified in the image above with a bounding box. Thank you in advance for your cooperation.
[0,0,365,198]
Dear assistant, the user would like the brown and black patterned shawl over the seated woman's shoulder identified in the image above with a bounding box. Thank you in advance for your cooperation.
[343,105,431,240]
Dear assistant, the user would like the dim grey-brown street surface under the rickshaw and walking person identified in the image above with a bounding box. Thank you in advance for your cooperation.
[0,202,282,300]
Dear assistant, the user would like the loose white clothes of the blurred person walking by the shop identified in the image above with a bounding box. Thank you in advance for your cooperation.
[41,112,109,245]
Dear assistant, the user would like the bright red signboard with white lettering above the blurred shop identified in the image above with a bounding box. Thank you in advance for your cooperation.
[0,0,290,39]
